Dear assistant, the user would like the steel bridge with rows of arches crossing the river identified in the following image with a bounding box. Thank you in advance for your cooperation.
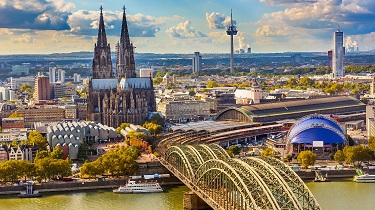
[160,144,321,210]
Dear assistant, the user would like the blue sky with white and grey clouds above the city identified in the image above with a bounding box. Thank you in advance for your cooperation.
[0,0,375,55]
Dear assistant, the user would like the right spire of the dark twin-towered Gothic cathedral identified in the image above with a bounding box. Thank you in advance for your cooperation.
[116,6,136,79]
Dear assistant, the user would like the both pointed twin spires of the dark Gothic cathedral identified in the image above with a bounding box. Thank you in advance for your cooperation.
[92,6,136,79]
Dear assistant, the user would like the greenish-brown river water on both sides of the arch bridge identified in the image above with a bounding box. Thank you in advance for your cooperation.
[0,179,375,210]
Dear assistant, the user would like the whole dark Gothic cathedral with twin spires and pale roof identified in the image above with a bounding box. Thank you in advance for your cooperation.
[87,7,156,127]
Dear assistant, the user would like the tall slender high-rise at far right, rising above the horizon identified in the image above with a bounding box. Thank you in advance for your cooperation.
[332,27,345,78]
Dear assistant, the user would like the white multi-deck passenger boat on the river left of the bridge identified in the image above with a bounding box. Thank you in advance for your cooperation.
[113,180,163,193]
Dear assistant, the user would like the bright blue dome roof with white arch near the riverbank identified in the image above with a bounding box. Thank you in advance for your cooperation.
[288,115,346,144]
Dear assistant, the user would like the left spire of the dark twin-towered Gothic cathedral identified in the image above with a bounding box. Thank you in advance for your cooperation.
[92,7,113,79]
